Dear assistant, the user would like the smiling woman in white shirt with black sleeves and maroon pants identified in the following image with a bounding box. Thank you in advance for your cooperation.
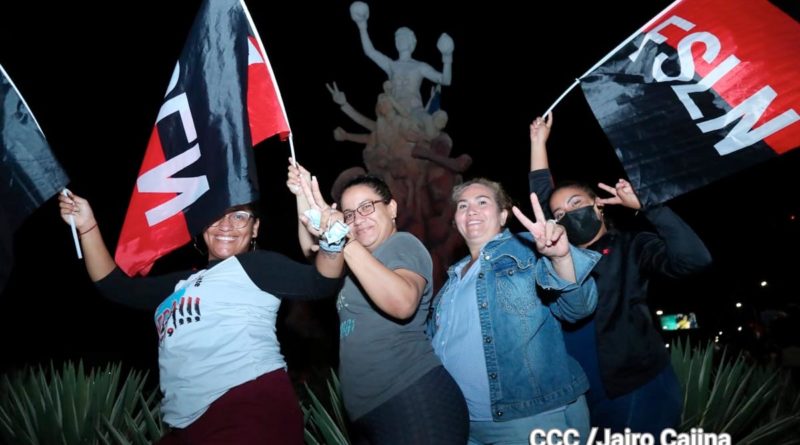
[59,189,344,445]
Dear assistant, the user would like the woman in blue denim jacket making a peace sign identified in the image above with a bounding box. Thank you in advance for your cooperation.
[430,178,599,444]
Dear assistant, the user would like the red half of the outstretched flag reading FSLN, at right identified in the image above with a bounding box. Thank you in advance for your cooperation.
[648,0,800,153]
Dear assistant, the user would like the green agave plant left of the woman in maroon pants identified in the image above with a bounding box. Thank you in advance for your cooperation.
[0,362,166,445]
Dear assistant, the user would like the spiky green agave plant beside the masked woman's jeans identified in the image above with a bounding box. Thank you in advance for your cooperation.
[671,340,800,445]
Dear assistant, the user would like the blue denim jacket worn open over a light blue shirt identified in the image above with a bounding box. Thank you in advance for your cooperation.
[429,229,600,421]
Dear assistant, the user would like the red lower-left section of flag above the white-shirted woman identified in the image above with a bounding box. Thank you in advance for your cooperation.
[114,127,192,276]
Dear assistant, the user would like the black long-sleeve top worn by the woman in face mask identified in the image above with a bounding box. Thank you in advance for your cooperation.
[528,169,711,397]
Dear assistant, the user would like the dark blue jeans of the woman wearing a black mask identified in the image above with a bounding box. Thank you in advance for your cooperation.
[589,365,683,435]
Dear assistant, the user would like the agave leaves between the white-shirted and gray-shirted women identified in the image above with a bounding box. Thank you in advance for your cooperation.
[301,370,350,445]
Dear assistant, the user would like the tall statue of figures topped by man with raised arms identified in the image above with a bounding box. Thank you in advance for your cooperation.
[326,1,472,288]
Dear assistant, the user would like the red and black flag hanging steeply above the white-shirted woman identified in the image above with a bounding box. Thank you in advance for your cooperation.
[115,0,289,276]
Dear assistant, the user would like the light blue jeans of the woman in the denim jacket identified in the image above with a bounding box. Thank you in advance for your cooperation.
[467,396,589,445]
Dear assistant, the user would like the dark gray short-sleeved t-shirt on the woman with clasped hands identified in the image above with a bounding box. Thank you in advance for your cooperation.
[336,232,441,420]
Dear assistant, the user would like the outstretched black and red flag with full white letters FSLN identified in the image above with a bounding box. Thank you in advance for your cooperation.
[581,0,800,204]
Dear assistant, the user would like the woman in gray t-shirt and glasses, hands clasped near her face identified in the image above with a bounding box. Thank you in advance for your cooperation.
[287,166,469,445]
